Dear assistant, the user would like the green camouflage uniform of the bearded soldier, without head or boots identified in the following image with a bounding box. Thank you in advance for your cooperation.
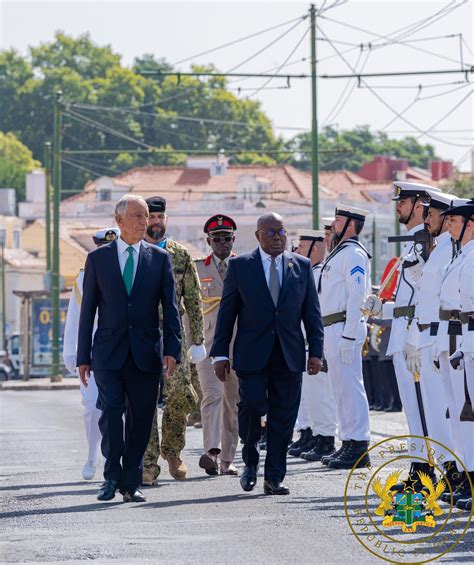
[144,239,204,476]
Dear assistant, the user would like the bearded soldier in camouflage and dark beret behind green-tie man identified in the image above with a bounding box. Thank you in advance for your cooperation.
[143,196,206,485]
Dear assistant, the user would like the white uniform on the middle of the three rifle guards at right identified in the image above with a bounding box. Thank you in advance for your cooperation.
[408,232,453,462]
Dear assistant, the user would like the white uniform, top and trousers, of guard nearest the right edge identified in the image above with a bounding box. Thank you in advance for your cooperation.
[437,241,474,471]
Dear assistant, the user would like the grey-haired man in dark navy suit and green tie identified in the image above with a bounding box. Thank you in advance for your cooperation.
[77,195,181,502]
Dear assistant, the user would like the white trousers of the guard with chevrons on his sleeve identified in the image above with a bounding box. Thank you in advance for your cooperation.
[324,323,370,441]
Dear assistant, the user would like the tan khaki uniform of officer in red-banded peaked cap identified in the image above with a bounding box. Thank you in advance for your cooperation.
[196,255,239,462]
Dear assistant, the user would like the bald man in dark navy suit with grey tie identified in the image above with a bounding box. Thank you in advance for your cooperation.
[210,213,323,494]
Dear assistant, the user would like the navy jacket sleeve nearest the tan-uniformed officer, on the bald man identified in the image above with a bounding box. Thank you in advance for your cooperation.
[209,259,240,357]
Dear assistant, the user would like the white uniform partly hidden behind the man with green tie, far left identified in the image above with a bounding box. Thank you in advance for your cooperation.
[63,271,102,462]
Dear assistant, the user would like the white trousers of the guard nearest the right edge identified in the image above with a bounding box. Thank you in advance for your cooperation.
[439,351,474,471]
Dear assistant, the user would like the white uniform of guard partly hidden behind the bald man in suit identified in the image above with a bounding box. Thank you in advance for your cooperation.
[296,264,336,437]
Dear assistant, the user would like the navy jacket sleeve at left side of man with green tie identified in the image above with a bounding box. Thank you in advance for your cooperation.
[77,254,99,366]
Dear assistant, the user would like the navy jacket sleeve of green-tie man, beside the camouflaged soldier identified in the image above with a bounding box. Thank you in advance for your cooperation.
[161,253,181,362]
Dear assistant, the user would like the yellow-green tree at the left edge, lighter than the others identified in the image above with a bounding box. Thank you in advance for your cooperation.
[0,131,40,201]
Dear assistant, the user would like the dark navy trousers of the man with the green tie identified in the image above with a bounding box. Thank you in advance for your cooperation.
[94,352,160,491]
